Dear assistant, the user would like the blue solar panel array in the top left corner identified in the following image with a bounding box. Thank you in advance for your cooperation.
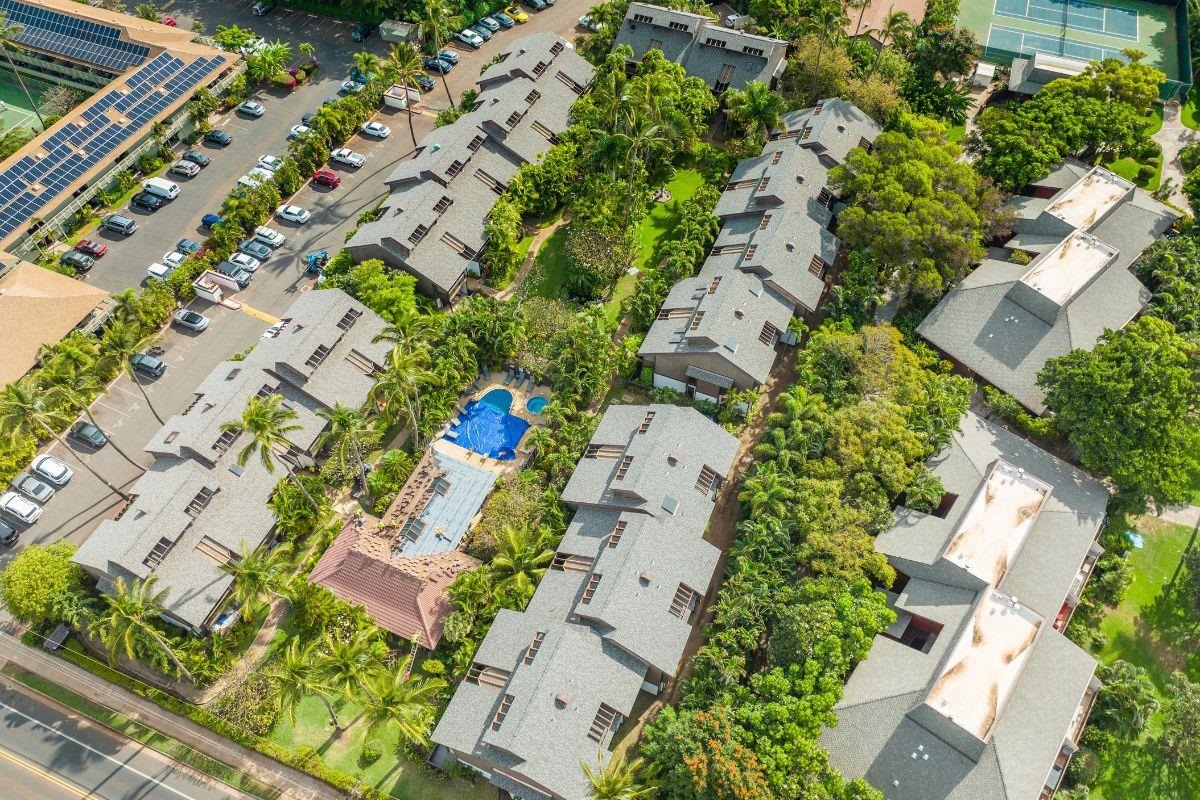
[0,0,150,72]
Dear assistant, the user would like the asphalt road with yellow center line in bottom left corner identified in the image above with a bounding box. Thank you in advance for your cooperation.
[0,681,248,800]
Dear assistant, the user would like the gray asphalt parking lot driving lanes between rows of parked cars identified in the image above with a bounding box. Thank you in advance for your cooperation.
[0,0,590,575]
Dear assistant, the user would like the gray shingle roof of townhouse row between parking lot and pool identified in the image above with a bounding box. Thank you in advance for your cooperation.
[74,289,389,630]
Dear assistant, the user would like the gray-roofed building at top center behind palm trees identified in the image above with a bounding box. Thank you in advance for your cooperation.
[614,2,787,89]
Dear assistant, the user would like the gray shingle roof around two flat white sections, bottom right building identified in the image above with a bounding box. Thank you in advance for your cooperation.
[821,414,1108,800]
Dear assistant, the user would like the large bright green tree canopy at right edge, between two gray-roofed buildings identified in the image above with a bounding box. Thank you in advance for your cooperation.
[1038,317,1200,507]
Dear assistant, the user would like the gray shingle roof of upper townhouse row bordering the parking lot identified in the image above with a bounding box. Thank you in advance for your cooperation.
[347,34,594,295]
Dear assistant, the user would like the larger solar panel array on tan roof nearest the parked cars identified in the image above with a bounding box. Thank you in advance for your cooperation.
[0,52,224,239]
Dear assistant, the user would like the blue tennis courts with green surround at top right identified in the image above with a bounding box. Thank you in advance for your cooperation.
[959,0,1190,96]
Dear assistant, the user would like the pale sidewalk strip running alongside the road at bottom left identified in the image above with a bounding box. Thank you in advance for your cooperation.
[0,633,346,800]
